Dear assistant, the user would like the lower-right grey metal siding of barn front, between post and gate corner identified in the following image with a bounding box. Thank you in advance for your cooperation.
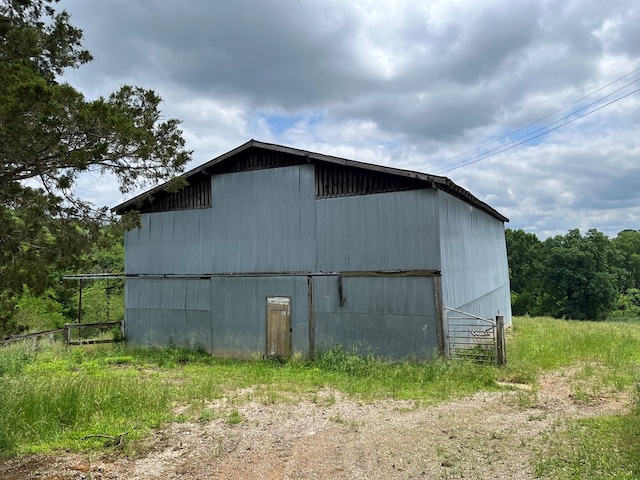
[313,277,438,359]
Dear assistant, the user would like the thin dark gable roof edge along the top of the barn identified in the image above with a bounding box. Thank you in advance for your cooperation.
[111,139,509,222]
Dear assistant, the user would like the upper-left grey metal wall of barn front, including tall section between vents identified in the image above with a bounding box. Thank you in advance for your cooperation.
[125,165,316,274]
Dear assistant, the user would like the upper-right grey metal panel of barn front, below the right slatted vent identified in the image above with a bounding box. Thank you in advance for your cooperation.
[316,190,440,271]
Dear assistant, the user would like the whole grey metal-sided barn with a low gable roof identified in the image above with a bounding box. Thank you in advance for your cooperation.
[113,140,511,359]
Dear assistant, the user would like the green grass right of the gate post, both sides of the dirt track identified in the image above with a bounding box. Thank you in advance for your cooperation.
[506,317,640,480]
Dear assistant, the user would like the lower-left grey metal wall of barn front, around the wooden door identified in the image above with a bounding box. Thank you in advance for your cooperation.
[125,276,309,357]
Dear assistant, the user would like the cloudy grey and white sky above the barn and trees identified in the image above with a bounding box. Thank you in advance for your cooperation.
[59,0,640,239]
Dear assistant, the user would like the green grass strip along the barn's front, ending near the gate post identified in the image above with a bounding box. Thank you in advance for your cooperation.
[0,342,499,457]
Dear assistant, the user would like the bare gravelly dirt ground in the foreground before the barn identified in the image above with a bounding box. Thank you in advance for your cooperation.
[0,371,630,480]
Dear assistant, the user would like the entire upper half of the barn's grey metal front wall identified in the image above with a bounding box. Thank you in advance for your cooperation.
[125,165,440,274]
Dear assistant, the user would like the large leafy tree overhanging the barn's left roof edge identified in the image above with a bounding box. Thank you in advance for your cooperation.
[0,0,191,333]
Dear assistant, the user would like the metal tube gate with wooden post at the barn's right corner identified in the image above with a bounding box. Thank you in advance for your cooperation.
[445,307,506,365]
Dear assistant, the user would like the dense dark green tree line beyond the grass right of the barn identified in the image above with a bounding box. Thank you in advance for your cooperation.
[506,229,640,320]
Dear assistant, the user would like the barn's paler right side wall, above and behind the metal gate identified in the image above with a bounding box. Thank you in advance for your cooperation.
[438,192,511,325]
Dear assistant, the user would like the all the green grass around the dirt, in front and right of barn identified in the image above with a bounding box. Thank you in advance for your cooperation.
[0,317,640,478]
